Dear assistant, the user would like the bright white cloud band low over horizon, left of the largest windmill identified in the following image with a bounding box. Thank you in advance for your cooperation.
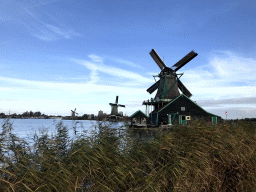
[0,74,150,115]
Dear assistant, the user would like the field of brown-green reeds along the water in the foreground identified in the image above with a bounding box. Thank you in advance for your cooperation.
[0,119,256,192]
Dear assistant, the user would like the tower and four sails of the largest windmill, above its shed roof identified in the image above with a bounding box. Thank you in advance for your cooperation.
[147,49,198,100]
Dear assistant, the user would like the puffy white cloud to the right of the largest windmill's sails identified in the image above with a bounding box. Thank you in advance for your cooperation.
[181,51,256,89]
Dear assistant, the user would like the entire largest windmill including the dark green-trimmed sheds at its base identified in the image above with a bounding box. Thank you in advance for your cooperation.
[130,49,221,127]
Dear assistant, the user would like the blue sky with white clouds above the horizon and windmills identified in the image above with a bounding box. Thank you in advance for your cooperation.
[0,0,256,119]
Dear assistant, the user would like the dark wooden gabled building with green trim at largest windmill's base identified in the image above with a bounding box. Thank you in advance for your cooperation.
[149,94,221,126]
